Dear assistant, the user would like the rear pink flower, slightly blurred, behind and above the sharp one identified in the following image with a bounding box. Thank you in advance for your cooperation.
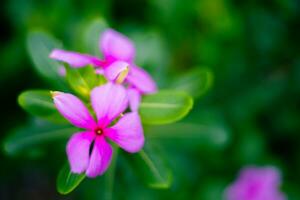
[50,29,156,111]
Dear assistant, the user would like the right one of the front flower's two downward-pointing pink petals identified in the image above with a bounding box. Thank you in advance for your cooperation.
[86,137,113,178]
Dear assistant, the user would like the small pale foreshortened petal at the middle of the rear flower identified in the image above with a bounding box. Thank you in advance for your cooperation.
[104,61,129,81]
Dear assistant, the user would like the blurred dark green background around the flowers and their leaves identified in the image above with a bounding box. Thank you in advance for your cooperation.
[0,0,300,200]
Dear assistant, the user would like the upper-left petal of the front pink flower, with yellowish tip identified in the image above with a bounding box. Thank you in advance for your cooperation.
[51,92,97,129]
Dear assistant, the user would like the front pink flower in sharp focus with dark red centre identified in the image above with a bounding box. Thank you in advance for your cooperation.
[52,83,144,177]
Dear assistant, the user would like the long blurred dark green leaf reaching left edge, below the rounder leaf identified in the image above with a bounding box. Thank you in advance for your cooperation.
[3,121,78,156]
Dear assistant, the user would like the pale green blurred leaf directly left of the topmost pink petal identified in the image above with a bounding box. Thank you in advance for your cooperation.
[83,18,108,56]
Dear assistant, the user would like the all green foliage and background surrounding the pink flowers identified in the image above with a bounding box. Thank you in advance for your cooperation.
[0,0,300,200]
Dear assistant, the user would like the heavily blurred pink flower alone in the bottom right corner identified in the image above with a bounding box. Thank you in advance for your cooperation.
[225,167,286,200]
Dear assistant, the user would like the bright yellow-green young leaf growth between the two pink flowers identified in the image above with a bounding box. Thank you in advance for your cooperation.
[66,66,103,99]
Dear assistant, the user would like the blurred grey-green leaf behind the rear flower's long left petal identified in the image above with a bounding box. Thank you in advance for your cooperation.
[27,31,66,88]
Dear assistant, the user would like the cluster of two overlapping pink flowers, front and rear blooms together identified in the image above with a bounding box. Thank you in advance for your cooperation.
[50,29,156,177]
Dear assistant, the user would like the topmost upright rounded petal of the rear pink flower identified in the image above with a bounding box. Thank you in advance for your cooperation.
[100,29,135,62]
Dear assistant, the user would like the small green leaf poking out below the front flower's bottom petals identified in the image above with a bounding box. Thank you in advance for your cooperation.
[56,163,85,194]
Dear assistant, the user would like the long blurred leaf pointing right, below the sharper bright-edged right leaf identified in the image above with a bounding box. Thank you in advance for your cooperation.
[156,107,232,152]
